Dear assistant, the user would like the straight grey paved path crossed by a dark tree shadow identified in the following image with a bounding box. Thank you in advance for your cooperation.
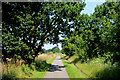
[44,56,69,80]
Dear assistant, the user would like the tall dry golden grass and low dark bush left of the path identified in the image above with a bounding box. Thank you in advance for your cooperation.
[2,54,55,80]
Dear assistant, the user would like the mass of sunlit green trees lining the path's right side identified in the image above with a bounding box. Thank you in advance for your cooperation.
[62,2,120,64]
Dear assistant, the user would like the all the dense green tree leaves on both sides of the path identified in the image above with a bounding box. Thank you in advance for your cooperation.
[2,2,120,63]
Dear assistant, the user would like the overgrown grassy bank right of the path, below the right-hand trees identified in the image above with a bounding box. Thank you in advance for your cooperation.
[65,56,120,80]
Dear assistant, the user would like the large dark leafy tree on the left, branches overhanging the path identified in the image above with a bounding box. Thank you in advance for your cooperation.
[2,2,85,63]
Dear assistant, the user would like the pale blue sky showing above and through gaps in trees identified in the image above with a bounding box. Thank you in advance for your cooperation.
[43,0,105,50]
